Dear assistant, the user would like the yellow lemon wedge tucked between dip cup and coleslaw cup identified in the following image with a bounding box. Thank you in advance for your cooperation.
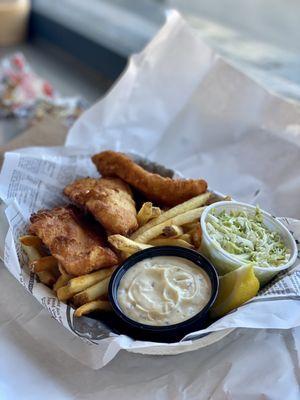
[211,265,259,318]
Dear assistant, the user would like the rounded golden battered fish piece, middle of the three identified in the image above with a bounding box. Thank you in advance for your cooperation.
[64,178,138,235]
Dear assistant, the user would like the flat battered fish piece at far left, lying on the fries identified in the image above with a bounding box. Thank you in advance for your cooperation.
[29,206,118,275]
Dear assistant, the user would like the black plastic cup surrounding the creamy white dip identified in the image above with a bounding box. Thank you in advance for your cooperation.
[108,246,219,343]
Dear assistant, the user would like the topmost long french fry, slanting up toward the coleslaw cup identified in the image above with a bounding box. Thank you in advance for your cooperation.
[130,192,211,240]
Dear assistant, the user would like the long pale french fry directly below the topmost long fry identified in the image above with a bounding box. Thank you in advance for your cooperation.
[135,207,205,243]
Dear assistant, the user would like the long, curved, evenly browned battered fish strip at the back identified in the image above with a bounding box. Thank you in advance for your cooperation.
[92,151,207,207]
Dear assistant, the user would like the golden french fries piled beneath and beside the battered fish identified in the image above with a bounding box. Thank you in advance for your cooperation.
[20,192,230,317]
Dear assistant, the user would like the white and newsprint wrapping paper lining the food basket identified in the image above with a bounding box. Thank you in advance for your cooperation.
[0,14,300,368]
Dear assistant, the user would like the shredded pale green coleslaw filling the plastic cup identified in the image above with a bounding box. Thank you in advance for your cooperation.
[206,208,290,267]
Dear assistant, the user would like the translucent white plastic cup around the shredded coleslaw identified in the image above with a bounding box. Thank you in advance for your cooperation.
[200,201,298,286]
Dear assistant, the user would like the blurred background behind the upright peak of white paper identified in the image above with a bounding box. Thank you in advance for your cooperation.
[0,0,300,145]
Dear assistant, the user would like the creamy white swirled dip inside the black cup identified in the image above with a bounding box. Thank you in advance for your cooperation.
[118,256,211,326]
